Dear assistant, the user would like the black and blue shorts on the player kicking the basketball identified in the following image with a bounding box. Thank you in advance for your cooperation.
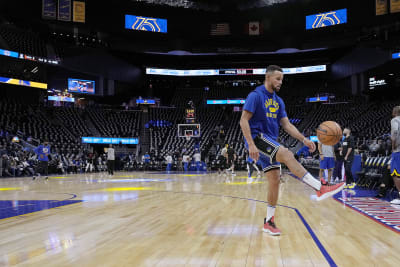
[246,134,281,172]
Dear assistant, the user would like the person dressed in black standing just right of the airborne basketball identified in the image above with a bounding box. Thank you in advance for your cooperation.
[342,128,356,189]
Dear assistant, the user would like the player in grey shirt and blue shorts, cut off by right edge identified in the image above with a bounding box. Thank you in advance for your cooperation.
[390,106,400,205]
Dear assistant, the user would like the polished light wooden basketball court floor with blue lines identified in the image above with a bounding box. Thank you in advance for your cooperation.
[0,172,400,267]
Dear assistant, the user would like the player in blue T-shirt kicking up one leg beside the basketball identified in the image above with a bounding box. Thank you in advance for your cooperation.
[240,65,344,235]
